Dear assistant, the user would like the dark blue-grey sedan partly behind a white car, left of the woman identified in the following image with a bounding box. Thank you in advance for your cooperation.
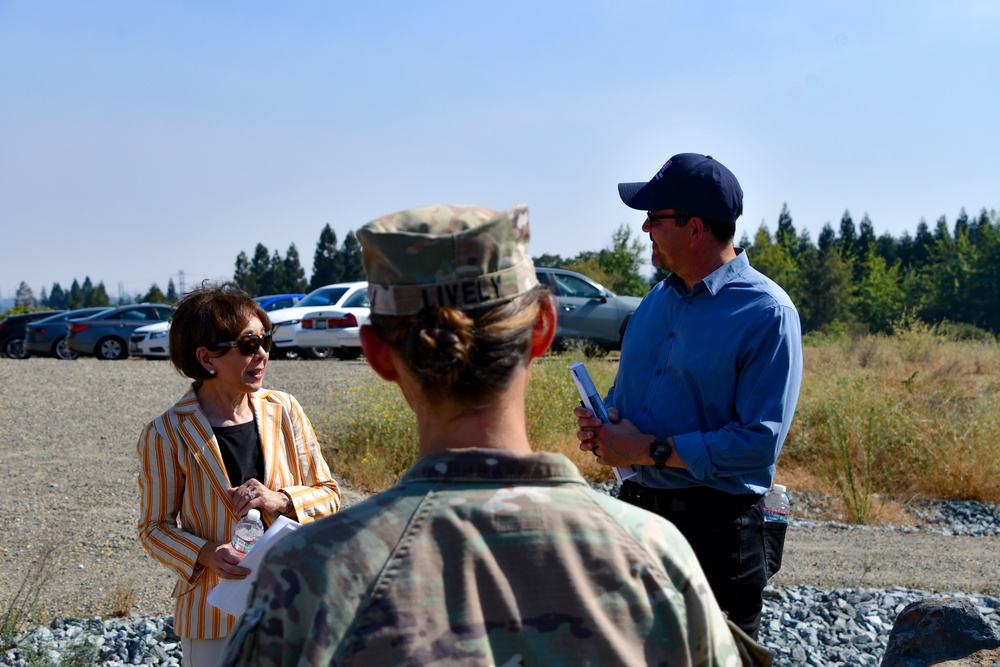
[66,303,173,359]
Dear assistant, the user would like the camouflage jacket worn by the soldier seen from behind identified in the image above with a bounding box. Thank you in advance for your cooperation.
[223,449,759,666]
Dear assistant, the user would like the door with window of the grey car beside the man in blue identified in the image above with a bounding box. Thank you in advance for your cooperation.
[548,272,619,345]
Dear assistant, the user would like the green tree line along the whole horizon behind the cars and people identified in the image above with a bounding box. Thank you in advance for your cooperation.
[15,205,1000,336]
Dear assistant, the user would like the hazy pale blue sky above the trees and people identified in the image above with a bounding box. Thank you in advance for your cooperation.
[0,0,1000,298]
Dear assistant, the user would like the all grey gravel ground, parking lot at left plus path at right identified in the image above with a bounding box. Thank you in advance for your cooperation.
[0,358,1000,636]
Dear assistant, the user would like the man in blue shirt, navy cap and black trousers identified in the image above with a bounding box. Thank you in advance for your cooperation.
[575,153,802,636]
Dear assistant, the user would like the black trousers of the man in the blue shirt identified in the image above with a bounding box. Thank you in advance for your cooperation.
[619,481,785,639]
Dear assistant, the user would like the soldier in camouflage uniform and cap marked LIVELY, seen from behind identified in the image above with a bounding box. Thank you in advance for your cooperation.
[224,206,769,666]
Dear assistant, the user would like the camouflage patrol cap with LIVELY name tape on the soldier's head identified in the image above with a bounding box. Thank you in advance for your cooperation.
[357,204,538,315]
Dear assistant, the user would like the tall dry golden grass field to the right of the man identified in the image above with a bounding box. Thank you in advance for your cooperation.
[779,323,1000,502]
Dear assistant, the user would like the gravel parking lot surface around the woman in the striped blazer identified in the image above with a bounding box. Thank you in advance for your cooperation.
[0,358,369,616]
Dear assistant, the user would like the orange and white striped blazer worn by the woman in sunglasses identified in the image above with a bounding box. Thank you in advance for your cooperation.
[136,386,340,639]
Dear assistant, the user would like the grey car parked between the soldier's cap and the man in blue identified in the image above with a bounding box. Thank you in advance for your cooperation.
[535,267,642,350]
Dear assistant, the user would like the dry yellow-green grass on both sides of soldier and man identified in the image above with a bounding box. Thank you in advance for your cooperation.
[317,322,1000,523]
